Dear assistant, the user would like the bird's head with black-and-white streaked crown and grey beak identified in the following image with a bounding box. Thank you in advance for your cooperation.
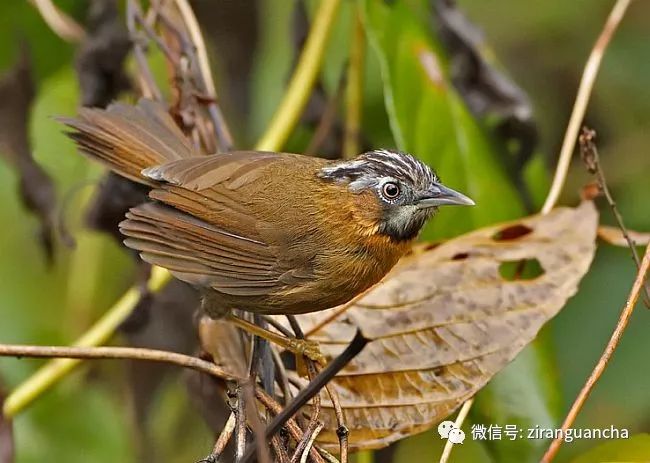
[318,150,474,241]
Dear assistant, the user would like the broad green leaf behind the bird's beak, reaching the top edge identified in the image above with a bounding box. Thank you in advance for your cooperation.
[362,0,523,239]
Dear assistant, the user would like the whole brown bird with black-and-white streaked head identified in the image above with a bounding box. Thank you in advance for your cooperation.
[62,100,474,317]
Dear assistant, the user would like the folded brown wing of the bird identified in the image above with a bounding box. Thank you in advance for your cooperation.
[120,151,318,296]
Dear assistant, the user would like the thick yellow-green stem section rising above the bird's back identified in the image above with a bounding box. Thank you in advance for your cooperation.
[256,0,341,151]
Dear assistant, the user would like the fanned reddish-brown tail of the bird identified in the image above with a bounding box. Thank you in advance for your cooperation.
[58,99,198,186]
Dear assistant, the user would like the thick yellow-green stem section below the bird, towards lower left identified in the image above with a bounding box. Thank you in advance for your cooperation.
[3,267,170,417]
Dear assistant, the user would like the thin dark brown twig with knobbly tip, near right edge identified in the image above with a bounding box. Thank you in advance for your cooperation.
[579,127,650,308]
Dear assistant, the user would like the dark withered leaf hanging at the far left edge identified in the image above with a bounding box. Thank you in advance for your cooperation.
[0,48,58,261]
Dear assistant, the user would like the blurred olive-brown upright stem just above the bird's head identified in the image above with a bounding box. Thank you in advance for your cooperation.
[343,9,366,159]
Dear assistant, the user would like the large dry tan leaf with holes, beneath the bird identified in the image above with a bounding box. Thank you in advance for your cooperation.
[202,202,598,449]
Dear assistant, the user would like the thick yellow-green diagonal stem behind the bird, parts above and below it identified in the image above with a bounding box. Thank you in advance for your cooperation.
[2,0,340,417]
